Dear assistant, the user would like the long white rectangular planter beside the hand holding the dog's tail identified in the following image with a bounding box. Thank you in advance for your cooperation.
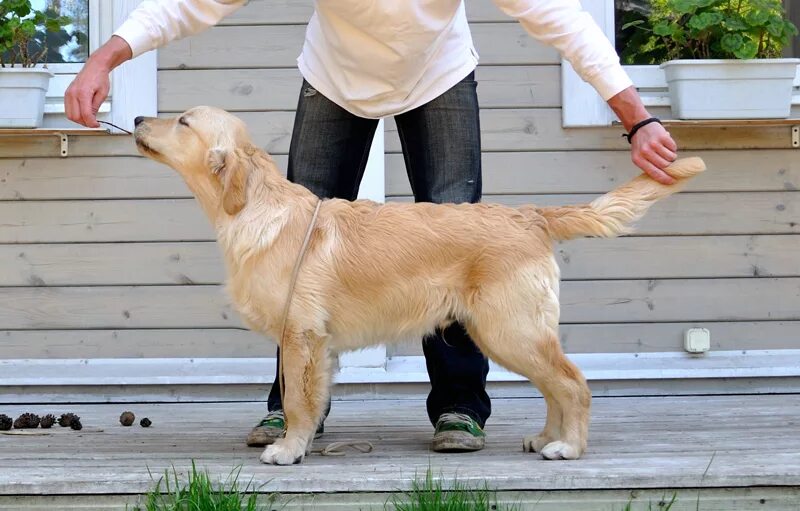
[661,59,800,119]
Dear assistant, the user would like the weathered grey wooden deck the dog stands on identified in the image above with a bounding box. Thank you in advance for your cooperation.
[0,394,800,510]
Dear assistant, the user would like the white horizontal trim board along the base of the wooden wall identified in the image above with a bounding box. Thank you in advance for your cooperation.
[0,349,800,388]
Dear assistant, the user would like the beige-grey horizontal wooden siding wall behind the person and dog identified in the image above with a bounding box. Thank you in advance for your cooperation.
[0,0,800,364]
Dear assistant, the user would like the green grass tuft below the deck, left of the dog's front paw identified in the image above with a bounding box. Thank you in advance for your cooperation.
[132,461,277,511]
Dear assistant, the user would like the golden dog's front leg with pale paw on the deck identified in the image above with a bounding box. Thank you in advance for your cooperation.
[261,332,330,465]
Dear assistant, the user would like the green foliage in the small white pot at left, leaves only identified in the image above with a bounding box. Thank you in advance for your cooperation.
[0,0,72,67]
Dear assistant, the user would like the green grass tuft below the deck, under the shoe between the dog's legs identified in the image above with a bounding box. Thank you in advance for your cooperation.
[386,468,515,511]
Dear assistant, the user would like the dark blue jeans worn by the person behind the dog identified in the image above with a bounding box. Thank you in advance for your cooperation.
[268,73,491,426]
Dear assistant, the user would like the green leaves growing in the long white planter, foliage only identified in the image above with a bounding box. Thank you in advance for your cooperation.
[621,0,798,64]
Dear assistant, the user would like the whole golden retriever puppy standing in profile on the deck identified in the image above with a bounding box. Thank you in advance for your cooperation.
[135,107,705,465]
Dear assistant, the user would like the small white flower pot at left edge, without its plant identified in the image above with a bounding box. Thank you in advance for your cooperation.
[0,67,53,128]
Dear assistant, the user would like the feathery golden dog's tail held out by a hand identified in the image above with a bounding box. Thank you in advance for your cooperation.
[519,158,706,241]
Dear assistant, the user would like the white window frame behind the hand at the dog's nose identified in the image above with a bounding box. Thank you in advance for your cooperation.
[44,0,158,128]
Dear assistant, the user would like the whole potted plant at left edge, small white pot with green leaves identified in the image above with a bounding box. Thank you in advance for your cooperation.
[0,0,70,128]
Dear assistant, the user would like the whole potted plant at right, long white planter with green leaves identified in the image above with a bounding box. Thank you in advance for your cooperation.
[623,0,800,119]
